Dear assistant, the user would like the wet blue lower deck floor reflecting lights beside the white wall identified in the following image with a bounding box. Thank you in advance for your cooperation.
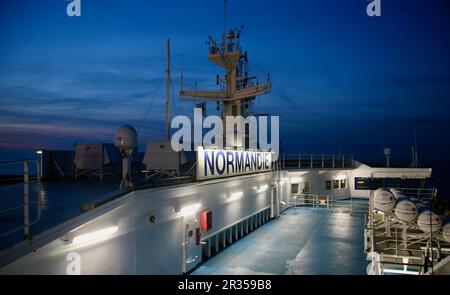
[192,208,368,275]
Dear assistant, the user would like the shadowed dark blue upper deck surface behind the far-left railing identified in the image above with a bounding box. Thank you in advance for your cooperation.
[0,180,120,249]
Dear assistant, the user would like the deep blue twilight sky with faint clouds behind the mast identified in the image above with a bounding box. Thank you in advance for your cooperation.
[0,0,450,166]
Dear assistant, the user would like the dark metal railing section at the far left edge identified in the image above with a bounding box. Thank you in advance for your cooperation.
[0,160,41,239]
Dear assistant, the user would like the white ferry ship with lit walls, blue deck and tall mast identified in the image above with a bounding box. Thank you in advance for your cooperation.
[0,17,450,274]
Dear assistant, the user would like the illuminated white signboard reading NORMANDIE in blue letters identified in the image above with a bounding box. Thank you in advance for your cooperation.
[197,147,272,180]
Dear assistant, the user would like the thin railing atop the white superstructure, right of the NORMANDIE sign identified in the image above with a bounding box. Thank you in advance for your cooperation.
[280,154,355,169]
